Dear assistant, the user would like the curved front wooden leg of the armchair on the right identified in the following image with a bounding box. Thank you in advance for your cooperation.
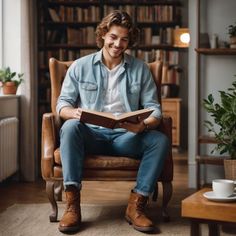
[162,182,173,222]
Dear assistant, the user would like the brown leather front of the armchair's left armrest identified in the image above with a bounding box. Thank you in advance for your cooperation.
[41,113,58,180]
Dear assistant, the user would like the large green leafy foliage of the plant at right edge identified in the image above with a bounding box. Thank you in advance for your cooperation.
[203,81,236,159]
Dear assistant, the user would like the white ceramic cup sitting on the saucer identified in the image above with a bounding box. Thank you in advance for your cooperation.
[212,179,235,197]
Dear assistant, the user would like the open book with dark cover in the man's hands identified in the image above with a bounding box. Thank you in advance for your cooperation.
[80,108,153,129]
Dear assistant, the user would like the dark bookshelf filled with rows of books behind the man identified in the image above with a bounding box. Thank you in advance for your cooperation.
[37,0,184,147]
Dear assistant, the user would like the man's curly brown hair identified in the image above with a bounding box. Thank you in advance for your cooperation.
[96,10,139,48]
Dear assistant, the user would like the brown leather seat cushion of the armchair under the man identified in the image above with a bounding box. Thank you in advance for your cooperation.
[54,148,140,170]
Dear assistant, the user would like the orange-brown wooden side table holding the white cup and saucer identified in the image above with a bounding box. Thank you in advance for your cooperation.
[181,188,236,236]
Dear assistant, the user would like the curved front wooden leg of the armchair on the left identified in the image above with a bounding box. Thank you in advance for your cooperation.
[46,181,58,222]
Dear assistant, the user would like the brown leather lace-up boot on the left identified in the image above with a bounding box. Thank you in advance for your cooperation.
[58,186,81,233]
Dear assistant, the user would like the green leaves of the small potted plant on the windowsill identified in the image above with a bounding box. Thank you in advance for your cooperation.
[0,67,24,87]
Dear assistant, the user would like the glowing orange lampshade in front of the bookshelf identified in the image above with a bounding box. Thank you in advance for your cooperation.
[174,28,190,48]
